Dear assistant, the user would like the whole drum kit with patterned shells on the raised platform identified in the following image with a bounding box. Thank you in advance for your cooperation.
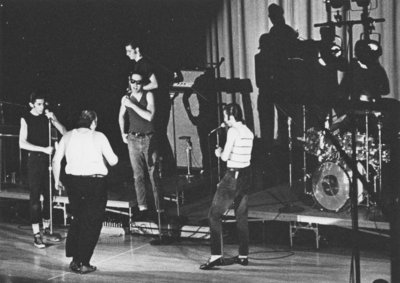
[298,100,390,212]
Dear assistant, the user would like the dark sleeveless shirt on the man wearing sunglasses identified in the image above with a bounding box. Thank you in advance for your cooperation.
[126,92,154,134]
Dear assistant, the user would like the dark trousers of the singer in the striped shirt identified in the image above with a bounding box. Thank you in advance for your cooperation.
[208,168,250,255]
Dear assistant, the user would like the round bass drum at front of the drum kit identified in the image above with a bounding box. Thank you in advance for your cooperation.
[312,162,365,212]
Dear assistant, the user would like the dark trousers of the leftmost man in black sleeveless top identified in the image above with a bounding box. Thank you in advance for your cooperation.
[27,152,50,224]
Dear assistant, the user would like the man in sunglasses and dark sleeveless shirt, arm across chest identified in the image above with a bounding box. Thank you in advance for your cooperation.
[118,73,163,224]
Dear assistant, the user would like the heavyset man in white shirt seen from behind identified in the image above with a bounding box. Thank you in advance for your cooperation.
[53,110,118,274]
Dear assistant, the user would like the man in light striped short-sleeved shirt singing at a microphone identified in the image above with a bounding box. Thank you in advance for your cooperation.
[200,104,254,270]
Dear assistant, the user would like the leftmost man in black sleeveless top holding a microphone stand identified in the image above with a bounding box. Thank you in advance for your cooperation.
[19,92,66,249]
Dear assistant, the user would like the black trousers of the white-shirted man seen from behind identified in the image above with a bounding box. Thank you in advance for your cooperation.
[65,175,107,265]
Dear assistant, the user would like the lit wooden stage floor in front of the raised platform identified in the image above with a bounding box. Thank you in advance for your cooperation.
[0,223,390,283]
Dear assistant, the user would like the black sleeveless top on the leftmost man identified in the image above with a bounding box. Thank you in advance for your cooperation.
[23,112,49,147]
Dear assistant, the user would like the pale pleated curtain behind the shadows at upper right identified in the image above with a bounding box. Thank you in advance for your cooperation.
[207,0,400,137]
